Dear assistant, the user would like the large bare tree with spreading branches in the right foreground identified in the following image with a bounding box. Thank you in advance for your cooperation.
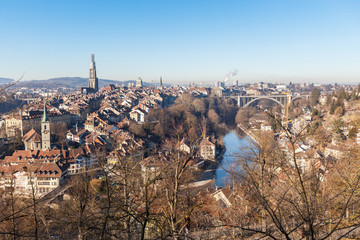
[223,116,360,239]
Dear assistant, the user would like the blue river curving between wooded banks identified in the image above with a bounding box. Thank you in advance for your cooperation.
[215,131,254,187]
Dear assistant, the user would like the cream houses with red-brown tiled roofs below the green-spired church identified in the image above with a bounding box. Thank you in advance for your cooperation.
[0,146,98,197]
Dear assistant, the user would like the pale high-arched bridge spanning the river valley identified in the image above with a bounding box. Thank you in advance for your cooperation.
[227,94,309,107]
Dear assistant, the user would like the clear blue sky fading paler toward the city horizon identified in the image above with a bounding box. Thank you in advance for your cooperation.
[0,0,360,83]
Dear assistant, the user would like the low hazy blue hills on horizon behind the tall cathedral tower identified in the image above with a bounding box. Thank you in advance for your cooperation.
[13,77,135,89]
